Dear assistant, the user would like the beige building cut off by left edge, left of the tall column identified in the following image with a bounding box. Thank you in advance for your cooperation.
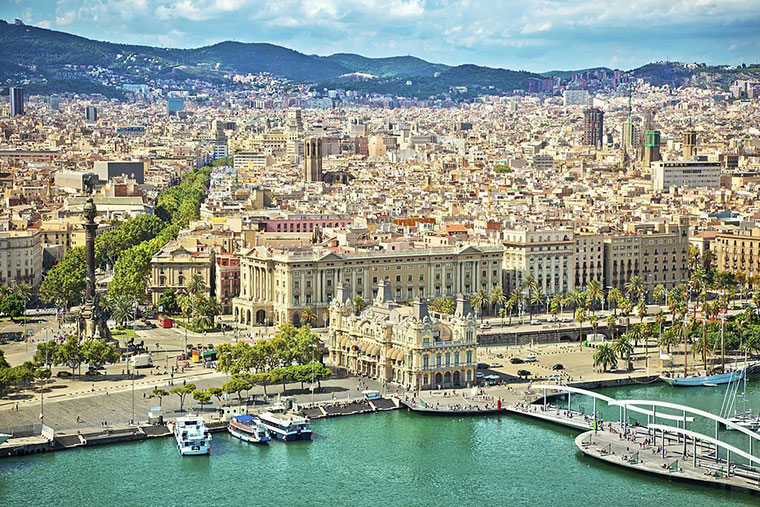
[0,231,42,287]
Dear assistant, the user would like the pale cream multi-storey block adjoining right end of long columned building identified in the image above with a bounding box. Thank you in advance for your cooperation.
[502,229,574,296]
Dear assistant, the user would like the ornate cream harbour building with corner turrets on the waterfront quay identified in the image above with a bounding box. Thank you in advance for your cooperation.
[328,282,478,389]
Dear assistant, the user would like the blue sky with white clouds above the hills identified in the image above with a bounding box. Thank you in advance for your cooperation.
[0,0,760,71]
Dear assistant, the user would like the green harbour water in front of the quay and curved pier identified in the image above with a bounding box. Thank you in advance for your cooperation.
[0,383,760,507]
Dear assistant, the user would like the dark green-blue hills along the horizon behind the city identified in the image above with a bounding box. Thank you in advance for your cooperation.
[0,20,760,98]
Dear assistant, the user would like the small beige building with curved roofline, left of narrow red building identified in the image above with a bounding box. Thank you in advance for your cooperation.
[150,241,216,305]
